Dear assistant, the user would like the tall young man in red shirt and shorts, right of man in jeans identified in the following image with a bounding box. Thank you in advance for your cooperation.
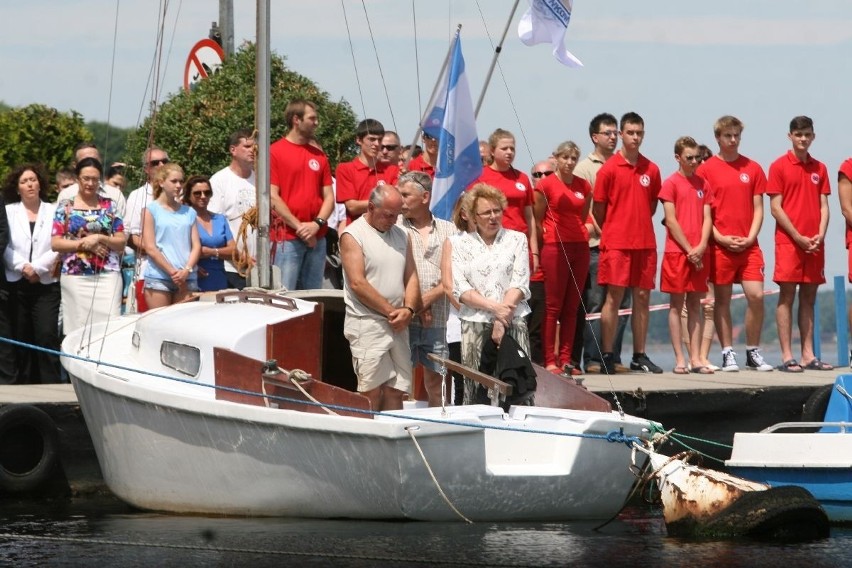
[594,112,663,374]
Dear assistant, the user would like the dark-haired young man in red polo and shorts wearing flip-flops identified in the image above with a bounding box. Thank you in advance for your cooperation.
[766,116,834,373]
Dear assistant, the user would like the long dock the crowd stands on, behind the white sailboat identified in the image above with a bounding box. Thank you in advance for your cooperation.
[0,367,850,495]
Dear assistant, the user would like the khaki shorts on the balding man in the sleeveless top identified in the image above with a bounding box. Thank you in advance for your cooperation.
[343,314,411,393]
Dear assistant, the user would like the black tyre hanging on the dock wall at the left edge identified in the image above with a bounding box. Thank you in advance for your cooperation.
[0,404,59,493]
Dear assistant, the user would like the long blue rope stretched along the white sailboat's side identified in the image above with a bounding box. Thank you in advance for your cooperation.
[0,337,652,447]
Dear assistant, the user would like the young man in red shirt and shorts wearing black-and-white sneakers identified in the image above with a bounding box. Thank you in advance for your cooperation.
[696,116,772,371]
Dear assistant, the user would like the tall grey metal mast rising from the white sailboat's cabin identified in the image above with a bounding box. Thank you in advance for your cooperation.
[255,0,272,290]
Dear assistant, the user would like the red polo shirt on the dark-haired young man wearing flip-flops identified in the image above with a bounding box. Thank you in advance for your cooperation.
[766,150,831,245]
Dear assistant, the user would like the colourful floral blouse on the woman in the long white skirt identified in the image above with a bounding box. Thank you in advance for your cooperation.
[51,195,124,275]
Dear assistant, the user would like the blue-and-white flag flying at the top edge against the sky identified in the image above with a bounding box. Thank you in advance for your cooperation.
[518,0,583,67]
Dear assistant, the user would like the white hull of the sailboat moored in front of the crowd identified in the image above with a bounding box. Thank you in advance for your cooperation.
[72,365,644,521]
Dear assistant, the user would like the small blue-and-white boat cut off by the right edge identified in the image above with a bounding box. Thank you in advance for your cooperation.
[725,375,852,523]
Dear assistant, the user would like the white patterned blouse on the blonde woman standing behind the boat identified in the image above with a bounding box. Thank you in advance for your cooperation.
[450,229,530,323]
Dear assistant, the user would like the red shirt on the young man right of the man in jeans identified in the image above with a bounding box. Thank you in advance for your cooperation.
[594,152,662,250]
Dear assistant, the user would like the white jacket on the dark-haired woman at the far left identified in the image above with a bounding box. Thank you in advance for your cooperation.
[3,201,58,284]
